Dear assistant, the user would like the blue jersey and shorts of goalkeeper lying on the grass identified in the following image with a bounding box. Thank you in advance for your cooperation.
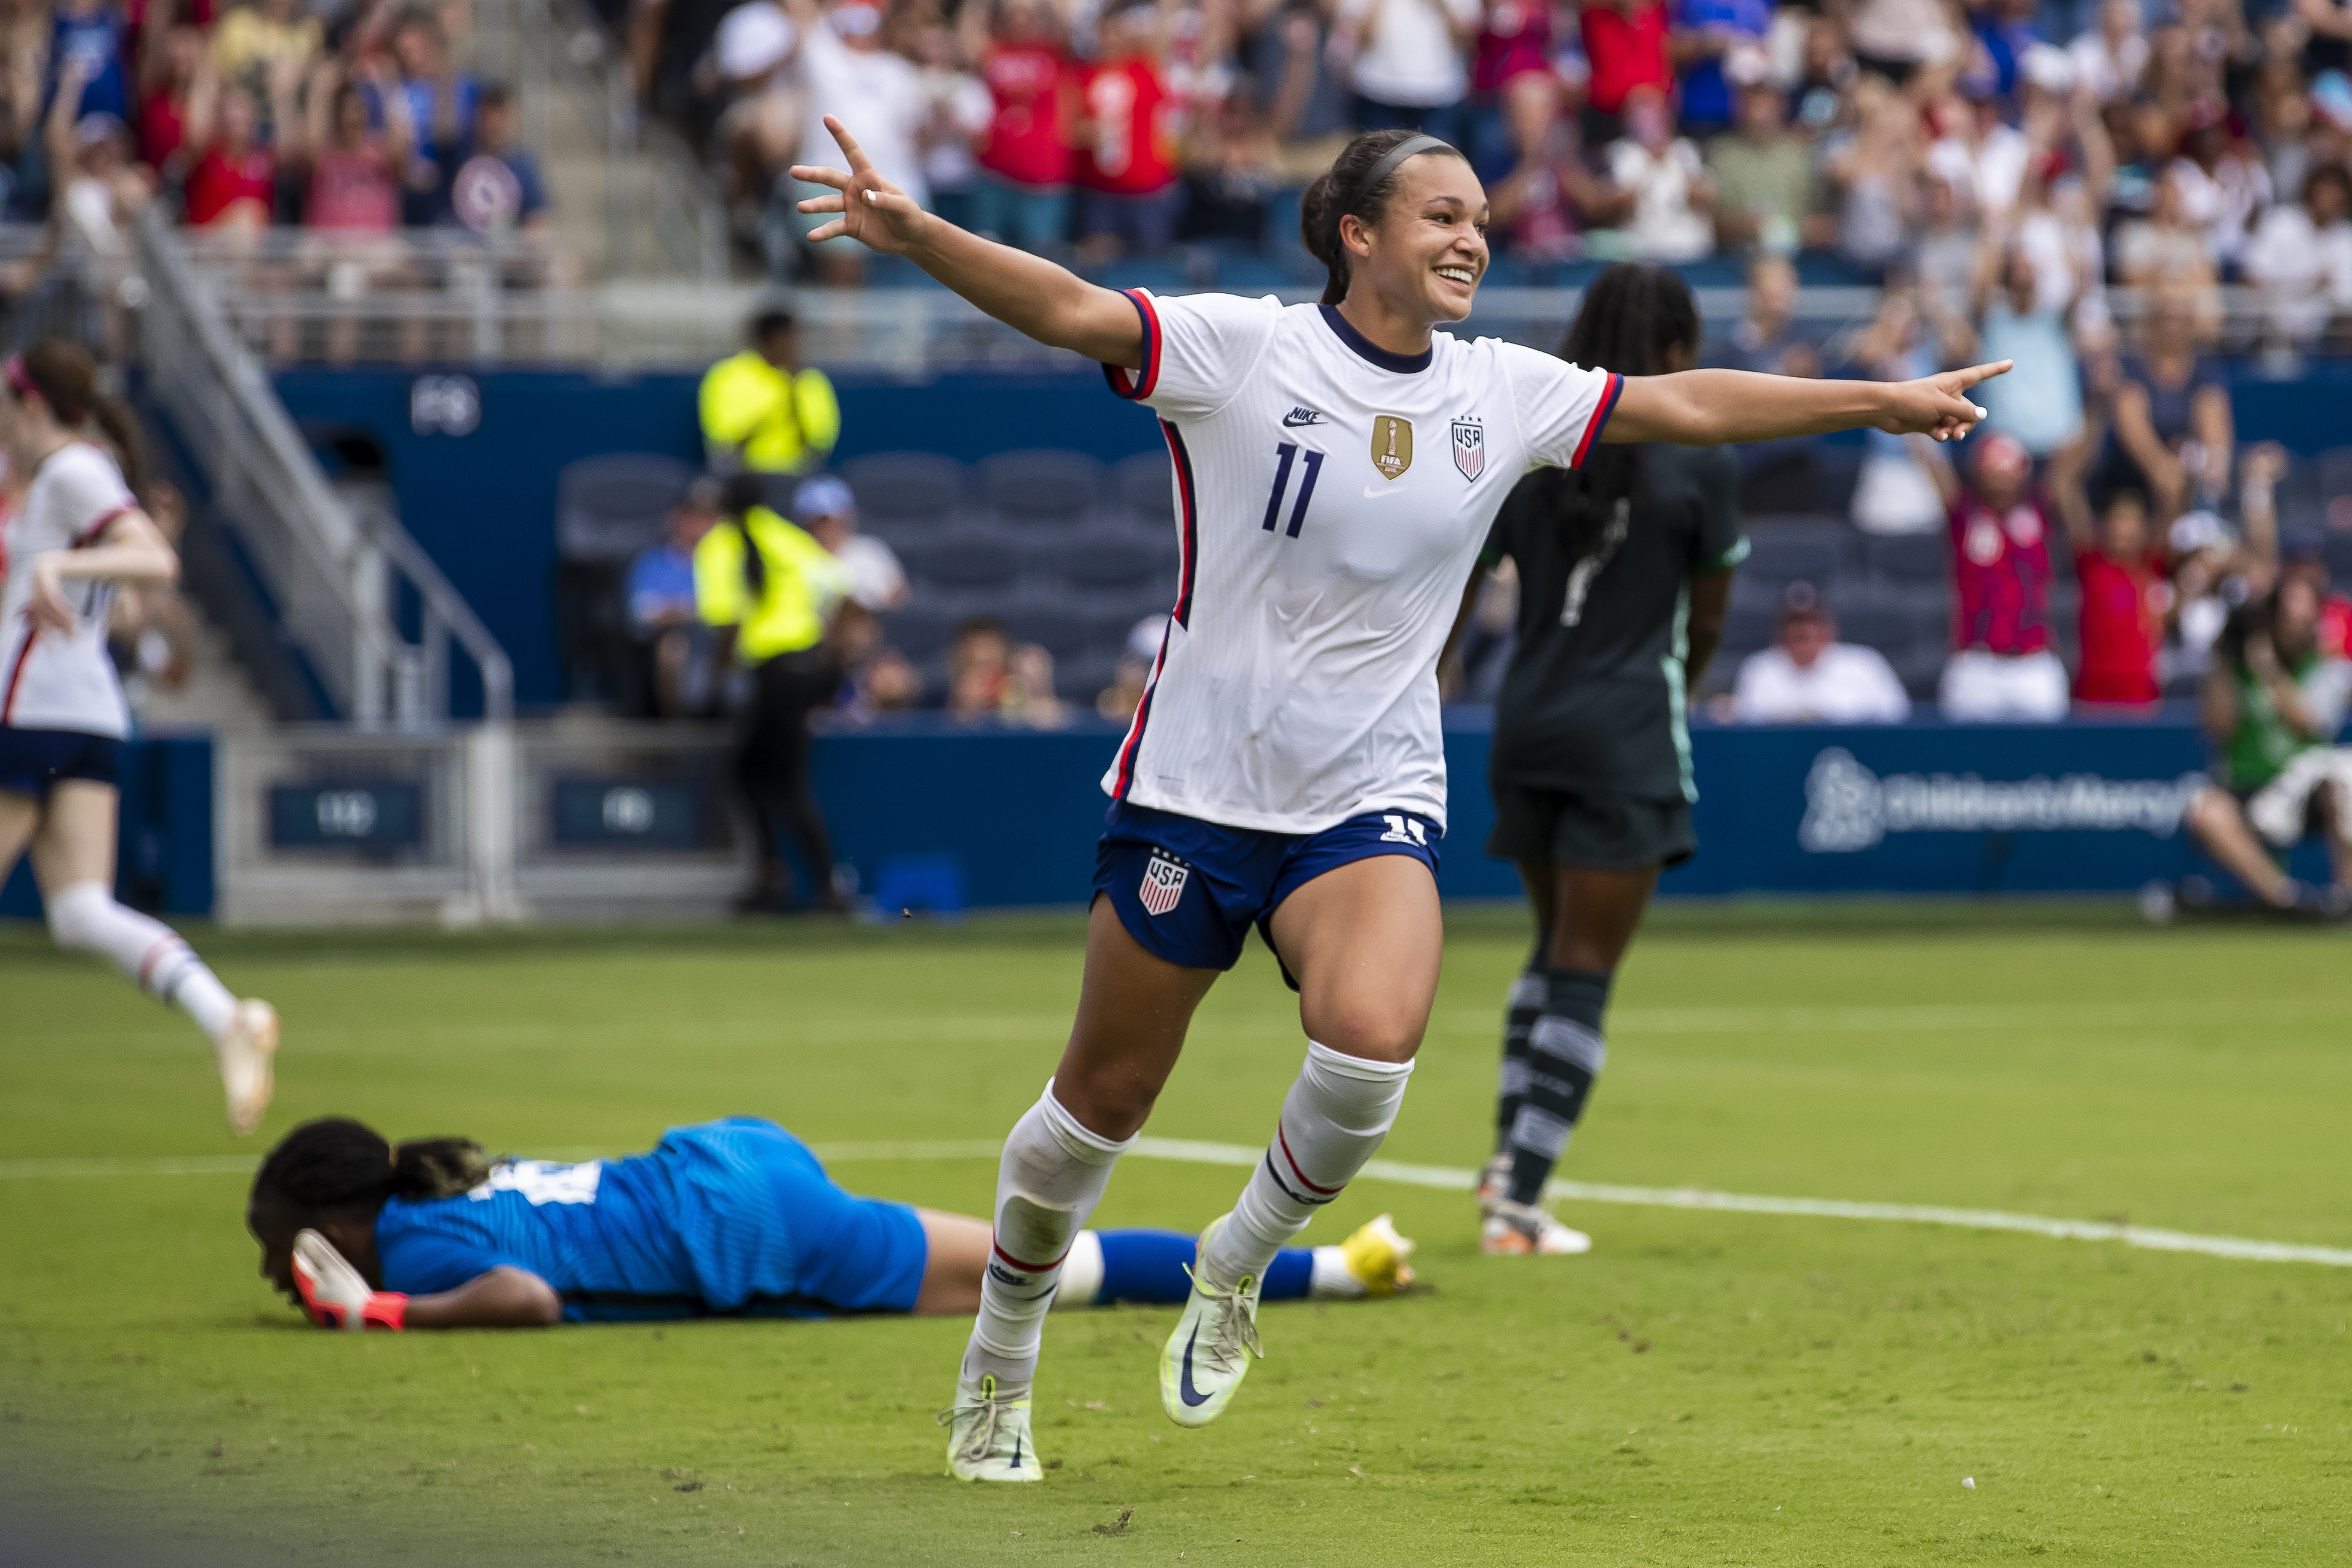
[377,1116,929,1321]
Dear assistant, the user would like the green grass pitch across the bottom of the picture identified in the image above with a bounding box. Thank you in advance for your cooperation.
[0,907,2352,1566]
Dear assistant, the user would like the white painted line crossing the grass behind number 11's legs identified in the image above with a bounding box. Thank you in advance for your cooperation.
[0,1138,2352,1269]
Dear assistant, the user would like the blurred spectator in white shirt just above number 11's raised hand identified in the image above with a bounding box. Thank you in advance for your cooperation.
[776,0,931,287]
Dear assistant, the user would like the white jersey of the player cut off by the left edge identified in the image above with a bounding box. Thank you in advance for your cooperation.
[0,442,139,738]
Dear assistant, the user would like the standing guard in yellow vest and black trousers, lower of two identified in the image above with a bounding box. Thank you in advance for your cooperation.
[694,472,849,912]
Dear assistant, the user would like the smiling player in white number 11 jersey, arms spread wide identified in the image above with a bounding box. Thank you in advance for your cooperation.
[793,118,2006,1481]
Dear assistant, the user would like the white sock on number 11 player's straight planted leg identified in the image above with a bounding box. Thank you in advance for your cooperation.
[964,1079,1136,1387]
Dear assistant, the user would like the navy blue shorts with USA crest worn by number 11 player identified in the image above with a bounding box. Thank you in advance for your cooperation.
[1094,802,1446,990]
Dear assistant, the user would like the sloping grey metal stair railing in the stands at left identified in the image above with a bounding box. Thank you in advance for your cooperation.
[134,209,515,729]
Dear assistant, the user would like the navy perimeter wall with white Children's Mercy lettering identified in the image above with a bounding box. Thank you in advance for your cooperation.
[0,708,2326,917]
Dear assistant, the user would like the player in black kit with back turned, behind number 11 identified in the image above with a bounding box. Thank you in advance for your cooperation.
[1463,263,1748,1253]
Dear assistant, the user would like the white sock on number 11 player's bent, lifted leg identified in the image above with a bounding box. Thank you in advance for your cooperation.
[1199,1042,1413,1290]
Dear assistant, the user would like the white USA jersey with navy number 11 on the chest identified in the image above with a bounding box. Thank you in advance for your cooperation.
[1103,289,1623,835]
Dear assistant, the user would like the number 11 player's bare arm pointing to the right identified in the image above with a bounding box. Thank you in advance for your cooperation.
[1602,360,2008,447]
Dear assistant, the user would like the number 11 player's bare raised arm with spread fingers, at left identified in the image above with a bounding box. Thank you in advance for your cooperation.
[793,115,1143,369]
